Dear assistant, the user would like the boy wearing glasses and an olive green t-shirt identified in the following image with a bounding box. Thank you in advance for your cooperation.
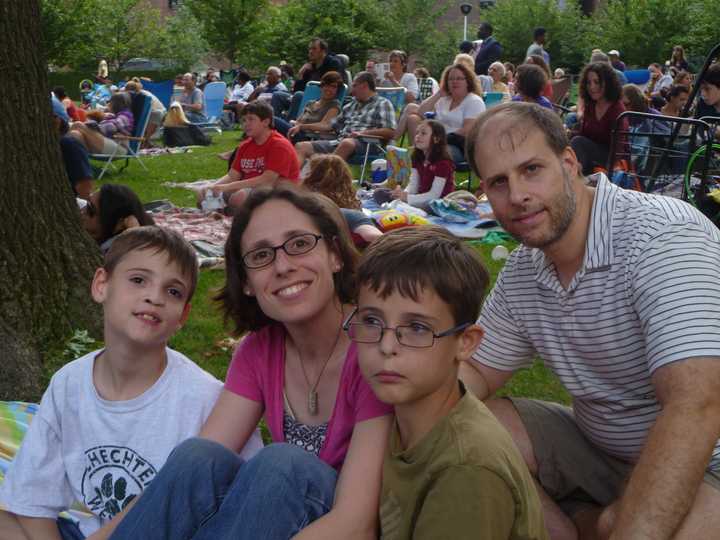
[345,227,548,540]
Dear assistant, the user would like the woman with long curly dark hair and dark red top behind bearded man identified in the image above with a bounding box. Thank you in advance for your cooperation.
[570,62,628,175]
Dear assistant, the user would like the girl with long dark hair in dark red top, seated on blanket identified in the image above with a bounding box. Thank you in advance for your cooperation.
[392,120,455,208]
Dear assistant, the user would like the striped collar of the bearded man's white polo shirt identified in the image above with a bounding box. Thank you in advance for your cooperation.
[531,173,620,282]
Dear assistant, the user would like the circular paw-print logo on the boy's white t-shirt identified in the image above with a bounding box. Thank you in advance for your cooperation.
[81,446,157,519]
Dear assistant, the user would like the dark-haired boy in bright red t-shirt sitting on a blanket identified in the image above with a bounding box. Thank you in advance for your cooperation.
[198,100,300,208]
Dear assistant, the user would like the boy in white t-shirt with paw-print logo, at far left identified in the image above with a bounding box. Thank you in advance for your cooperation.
[0,226,262,540]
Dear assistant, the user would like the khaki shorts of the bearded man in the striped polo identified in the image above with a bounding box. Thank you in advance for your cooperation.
[508,398,720,515]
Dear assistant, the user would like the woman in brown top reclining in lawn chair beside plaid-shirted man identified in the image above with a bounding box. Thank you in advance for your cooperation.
[273,71,343,143]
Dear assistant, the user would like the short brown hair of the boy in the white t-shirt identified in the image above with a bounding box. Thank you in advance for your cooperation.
[103,225,198,303]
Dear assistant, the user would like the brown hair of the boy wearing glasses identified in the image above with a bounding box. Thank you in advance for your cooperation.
[357,226,490,324]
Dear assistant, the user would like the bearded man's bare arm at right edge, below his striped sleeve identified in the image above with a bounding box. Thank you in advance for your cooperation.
[611,358,720,540]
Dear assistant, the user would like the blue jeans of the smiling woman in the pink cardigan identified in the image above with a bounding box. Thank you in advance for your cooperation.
[111,438,337,540]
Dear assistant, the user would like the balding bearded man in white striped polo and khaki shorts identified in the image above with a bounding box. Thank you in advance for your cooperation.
[462,103,720,540]
